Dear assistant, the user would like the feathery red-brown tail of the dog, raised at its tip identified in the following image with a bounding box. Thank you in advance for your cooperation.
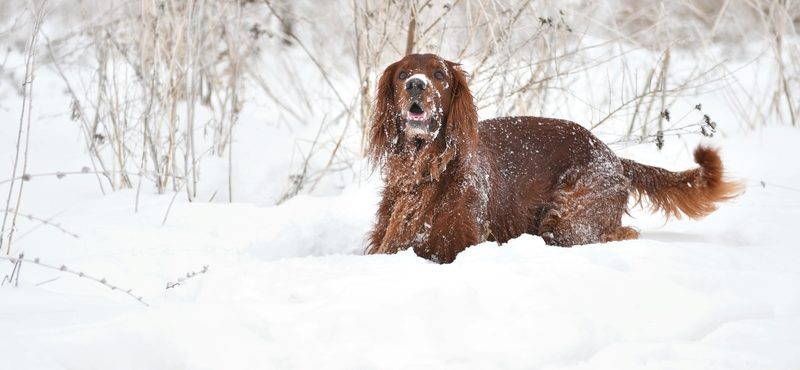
[621,146,743,218]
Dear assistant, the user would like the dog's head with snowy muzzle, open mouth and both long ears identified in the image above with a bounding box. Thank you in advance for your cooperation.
[368,54,477,163]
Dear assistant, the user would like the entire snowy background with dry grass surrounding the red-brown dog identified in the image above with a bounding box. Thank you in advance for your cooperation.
[0,0,800,370]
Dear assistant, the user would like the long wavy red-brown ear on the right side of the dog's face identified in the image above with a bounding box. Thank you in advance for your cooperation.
[445,61,478,153]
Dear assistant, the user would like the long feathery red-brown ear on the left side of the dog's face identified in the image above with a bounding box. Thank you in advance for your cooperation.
[367,62,400,166]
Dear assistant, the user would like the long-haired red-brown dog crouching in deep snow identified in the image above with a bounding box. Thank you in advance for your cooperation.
[367,54,739,263]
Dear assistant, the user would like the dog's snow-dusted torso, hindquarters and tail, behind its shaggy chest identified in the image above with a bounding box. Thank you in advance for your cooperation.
[478,117,740,246]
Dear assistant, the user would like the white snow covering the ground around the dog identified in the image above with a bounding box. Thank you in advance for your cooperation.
[0,10,800,370]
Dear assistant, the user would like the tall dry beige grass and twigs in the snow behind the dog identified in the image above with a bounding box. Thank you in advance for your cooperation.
[0,0,800,208]
